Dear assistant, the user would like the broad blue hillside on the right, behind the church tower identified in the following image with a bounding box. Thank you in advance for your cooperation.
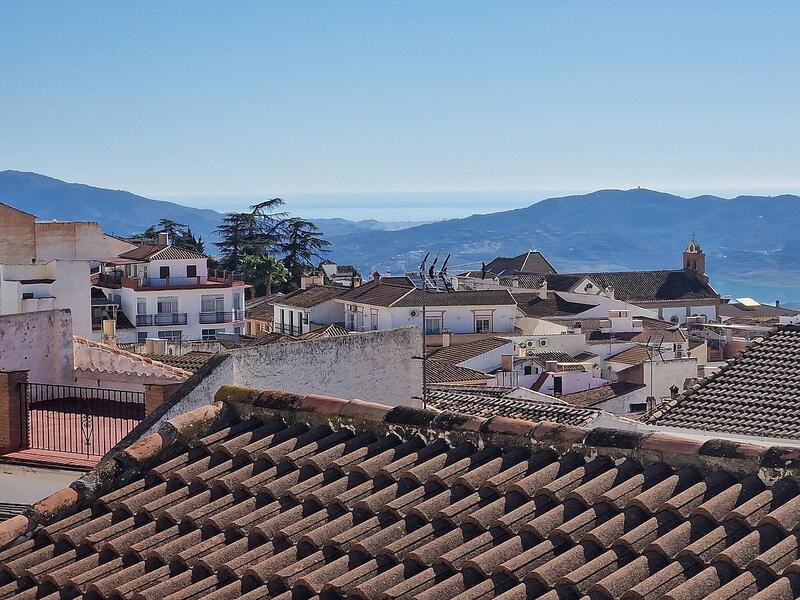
[322,189,800,300]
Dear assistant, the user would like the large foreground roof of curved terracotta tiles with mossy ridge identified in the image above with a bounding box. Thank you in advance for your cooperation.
[0,387,800,600]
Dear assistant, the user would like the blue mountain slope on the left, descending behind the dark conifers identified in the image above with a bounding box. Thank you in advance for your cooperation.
[0,171,222,238]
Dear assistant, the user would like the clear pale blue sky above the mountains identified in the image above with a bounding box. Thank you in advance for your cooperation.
[0,0,800,202]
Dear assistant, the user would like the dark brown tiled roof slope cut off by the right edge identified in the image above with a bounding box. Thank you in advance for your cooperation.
[645,326,800,439]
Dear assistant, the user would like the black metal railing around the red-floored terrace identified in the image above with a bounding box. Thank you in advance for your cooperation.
[19,383,145,457]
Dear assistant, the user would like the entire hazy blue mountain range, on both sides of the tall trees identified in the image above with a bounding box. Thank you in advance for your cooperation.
[0,171,800,301]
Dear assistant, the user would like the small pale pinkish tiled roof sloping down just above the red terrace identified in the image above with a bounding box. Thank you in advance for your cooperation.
[72,335,192,381]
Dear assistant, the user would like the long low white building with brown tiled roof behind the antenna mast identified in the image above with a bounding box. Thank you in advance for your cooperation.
[337,277,517,335]
